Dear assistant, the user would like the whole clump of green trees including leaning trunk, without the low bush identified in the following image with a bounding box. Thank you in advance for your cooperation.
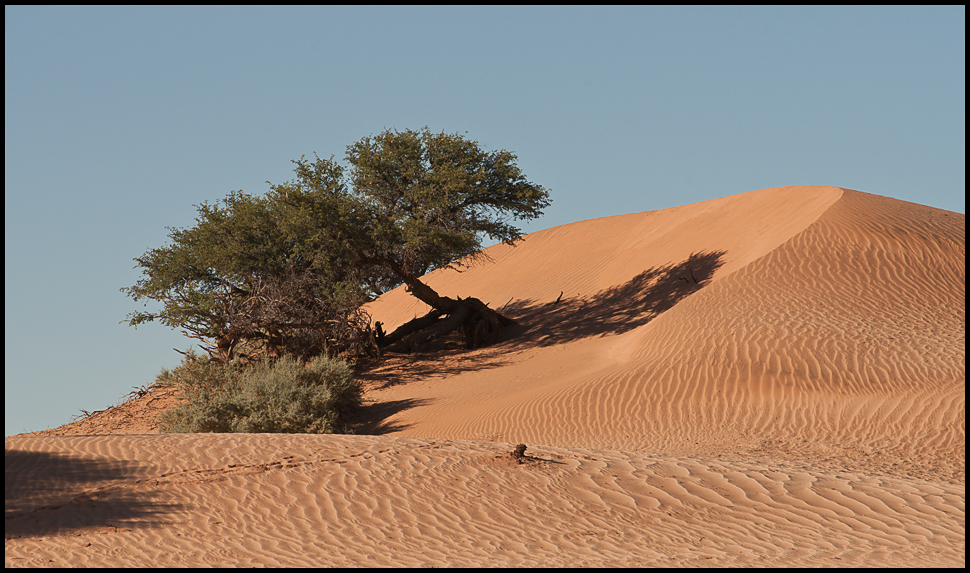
[122,127,550,360]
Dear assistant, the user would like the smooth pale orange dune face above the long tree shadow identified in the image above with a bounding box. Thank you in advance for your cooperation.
[366,187,842,331]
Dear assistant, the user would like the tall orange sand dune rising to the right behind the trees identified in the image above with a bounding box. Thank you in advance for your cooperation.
[362,187,966,479]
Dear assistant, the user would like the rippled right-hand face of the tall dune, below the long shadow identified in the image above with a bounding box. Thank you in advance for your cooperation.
[362,188,965,479]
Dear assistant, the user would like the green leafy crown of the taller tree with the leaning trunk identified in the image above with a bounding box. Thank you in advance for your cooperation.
[347,127,550,278]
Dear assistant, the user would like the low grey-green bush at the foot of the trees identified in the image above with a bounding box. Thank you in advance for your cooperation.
[159,353,361,434]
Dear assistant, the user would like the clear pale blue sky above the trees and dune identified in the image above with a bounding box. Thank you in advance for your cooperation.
[4,6,966,435]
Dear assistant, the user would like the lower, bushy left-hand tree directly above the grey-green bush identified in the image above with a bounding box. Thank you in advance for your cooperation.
[121,191,369,362]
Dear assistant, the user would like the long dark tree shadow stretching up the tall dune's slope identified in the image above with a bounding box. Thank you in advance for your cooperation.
[503,251,726,346]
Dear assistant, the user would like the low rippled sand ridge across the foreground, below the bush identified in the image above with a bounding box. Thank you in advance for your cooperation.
[4,434,964,567]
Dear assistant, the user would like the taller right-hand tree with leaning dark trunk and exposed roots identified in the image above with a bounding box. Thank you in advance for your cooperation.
[273,127,550,350]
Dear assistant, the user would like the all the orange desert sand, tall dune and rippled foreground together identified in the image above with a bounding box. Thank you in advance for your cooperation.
[4,187,966,567]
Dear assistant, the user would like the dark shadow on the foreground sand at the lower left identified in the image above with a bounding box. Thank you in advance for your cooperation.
[3,449,181,539]
